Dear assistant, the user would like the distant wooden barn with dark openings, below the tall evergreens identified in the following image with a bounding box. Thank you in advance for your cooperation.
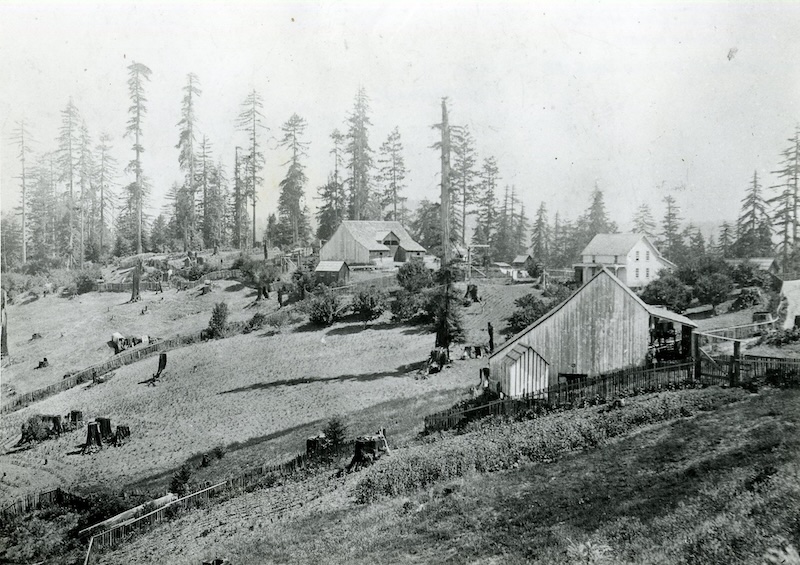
[319,220,425,265]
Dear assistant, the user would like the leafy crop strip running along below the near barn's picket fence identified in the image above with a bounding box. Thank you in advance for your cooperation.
[355,388,747,503]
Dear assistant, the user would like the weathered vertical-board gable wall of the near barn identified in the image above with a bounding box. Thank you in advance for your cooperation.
[489,270,651,394]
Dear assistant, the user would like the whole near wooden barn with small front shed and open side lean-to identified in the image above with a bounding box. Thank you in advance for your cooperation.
[489,269,697,396]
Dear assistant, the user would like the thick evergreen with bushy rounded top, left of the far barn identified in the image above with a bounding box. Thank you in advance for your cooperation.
[278,114,308,246]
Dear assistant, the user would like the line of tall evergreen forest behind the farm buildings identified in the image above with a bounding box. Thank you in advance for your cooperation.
[0,62,800,270]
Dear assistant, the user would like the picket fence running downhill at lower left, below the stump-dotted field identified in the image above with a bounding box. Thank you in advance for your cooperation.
[85,441,353,563]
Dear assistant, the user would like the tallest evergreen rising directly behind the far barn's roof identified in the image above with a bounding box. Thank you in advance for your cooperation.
[345,87,372,220]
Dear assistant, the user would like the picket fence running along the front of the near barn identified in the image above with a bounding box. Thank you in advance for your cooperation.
[425,363,729,432]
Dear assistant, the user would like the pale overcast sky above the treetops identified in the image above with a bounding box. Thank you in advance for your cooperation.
[0,0,800,236]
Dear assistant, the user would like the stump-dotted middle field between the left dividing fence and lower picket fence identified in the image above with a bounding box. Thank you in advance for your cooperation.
[0,312,482,497]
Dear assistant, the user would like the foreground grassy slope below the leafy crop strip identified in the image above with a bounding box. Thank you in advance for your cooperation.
[95,390,800,565]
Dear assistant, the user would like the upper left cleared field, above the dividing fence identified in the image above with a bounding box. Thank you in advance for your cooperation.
[2,280,270,398]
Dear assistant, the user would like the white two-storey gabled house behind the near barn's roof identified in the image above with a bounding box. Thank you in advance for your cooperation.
[573,233,675,288]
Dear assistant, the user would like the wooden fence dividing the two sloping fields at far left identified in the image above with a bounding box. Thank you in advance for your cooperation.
[0,333,200,414]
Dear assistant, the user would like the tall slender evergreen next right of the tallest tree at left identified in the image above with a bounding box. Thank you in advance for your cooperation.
[175,73,200,248]
